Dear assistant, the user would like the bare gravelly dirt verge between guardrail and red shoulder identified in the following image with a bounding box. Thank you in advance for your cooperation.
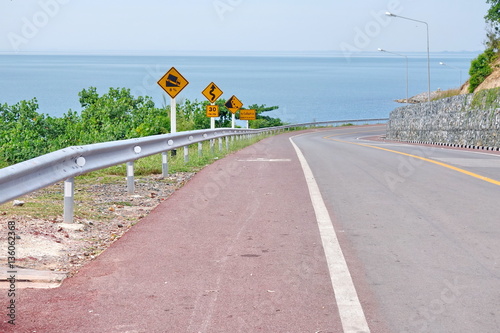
[0,172,194,276]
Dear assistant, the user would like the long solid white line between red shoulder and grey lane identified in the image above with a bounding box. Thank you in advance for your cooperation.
[290,137,370,333]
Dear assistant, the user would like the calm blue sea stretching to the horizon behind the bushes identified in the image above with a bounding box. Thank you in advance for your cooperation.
[0,53,477,123]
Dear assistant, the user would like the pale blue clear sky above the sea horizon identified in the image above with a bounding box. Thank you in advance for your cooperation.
[0,0,489,55]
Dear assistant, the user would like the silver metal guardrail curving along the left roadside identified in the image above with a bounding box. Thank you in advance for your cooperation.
[0,118,388,221]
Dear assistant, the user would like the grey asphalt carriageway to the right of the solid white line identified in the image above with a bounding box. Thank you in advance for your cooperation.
[293,128,500,333]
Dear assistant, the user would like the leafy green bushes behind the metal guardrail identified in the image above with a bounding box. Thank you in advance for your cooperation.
[0,87,282,167]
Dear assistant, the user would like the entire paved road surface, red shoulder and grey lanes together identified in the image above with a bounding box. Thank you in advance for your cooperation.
[0,126,500,333]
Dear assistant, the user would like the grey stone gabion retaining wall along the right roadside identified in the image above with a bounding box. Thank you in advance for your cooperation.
[387,88,500,150]
